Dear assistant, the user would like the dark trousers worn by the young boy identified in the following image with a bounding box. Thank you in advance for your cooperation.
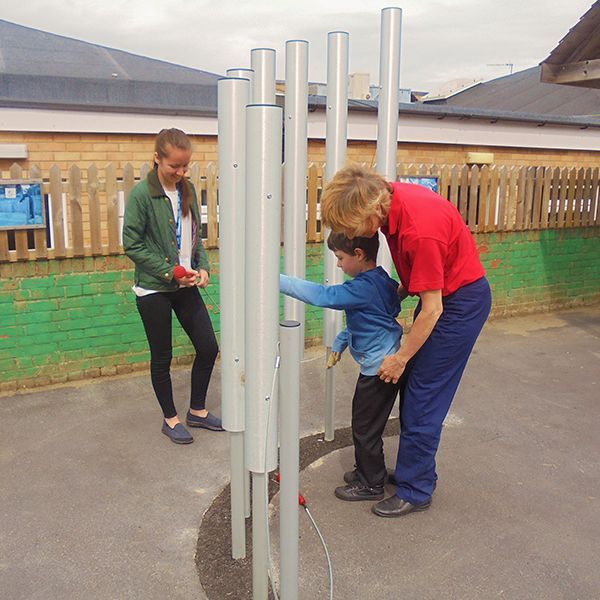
[352,375,403,487]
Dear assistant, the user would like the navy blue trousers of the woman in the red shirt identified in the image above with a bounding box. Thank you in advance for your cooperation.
[395,277,492,504]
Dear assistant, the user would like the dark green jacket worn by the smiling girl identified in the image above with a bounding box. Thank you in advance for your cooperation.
[123,170,209,292]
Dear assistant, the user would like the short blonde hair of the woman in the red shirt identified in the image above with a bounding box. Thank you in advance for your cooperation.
[321,165,391,237]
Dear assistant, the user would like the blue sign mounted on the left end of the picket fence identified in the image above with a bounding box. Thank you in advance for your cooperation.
[0,180,46,229]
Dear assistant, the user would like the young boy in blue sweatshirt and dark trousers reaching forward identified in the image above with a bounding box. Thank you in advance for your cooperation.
[280,233,402,501]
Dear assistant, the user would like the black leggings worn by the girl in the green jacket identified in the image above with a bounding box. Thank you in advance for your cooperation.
[136,287,219,419]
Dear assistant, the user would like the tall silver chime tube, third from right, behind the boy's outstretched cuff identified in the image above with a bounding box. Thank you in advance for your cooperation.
[283,40,308,356]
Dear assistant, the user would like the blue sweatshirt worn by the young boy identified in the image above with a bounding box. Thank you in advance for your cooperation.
[280,267,402,376]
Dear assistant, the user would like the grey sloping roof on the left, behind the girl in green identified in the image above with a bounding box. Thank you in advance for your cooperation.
[0,20,220,113]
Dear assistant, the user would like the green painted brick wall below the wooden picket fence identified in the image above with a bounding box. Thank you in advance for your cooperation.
[0,227,600,392]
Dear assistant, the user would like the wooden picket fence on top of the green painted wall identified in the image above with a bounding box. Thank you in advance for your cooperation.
[0,164,600,262]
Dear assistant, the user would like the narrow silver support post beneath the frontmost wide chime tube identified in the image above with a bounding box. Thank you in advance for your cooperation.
[252,473,269,600]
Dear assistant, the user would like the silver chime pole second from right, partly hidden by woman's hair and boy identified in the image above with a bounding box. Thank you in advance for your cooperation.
[323,31,349,441]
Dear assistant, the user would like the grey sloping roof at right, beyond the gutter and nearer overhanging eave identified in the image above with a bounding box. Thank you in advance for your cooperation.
[425,66,600,118]
